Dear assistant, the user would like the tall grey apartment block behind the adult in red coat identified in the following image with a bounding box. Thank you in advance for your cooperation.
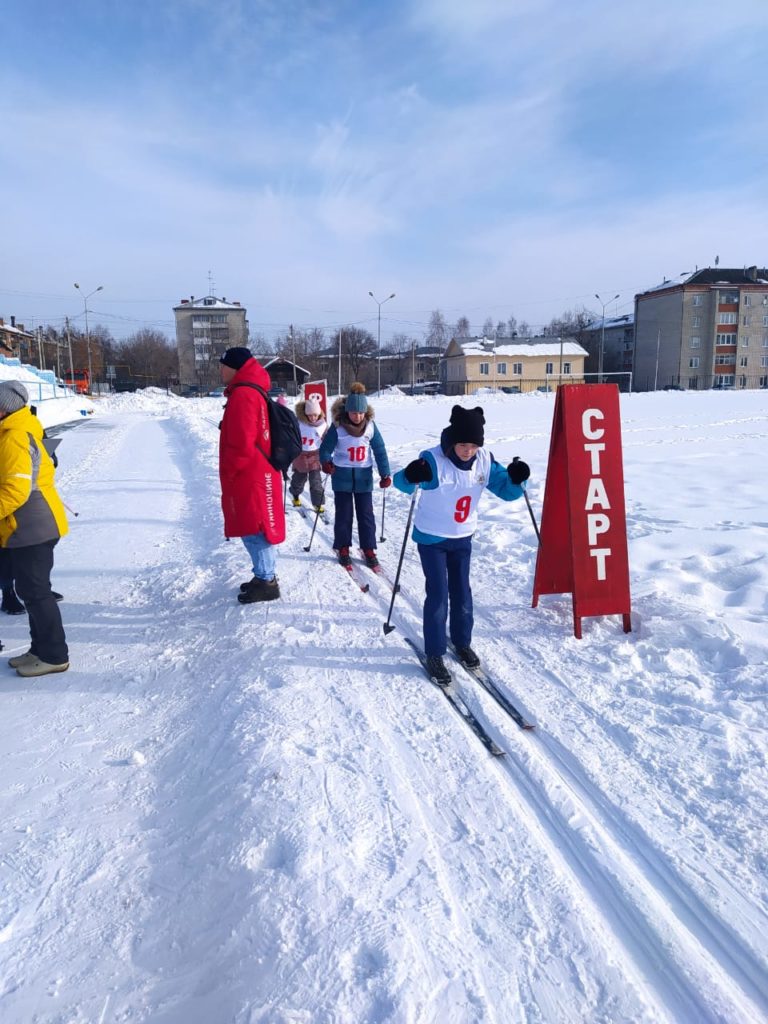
[173,295,248,391]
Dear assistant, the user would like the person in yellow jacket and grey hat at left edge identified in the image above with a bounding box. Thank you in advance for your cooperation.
[0,381,70,677]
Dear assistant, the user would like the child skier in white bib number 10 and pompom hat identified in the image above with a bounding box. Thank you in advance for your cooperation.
[321,383,392,568]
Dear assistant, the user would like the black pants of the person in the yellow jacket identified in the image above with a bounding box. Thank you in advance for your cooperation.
[6,541,70,665]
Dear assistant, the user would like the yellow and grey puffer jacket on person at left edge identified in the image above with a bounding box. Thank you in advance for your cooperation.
[0,406,69,548]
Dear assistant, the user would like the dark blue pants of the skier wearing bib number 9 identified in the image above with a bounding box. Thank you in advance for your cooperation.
[418,537,474,657]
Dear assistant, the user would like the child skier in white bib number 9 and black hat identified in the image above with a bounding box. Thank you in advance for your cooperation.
[393,406,530,686]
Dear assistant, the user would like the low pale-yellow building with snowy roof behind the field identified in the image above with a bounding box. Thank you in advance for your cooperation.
[440,337,587,394]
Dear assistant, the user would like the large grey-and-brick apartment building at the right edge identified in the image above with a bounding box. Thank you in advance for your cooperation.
[634,266,768,391]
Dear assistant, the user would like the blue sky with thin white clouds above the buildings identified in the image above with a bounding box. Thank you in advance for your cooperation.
[0,0,768,338]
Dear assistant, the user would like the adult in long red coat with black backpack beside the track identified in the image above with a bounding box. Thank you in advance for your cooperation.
[219,348,286,604]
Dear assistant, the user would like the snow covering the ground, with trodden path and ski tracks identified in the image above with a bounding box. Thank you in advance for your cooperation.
[0,392,768,1024]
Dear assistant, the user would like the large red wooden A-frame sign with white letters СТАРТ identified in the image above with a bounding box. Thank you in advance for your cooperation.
[534,384,632,639]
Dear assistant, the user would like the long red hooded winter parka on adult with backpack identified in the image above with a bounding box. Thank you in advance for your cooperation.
[219,358,286,544]
